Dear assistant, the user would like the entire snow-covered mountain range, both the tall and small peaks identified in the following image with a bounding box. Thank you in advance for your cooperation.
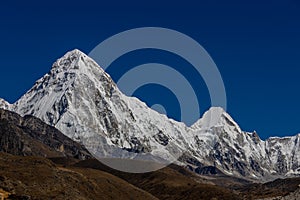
[7,50,300,179]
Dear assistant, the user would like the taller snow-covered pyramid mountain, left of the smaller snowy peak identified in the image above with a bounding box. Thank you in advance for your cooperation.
[13,50,188,171]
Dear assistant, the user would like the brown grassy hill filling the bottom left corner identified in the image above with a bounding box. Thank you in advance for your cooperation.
[0,153,156,200]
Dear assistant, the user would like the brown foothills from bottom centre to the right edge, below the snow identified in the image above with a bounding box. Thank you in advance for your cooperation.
[73,159,300,200]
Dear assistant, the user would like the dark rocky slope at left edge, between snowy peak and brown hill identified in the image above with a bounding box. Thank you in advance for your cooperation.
[0,109,91,159]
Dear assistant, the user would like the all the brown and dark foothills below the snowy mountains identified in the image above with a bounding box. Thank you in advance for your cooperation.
[0,109,300,200]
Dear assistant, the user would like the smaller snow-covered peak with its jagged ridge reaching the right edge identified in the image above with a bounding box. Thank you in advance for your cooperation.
[192,108,300,180]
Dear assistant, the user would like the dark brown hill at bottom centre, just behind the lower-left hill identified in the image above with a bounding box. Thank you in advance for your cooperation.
[74,160,240,200]
